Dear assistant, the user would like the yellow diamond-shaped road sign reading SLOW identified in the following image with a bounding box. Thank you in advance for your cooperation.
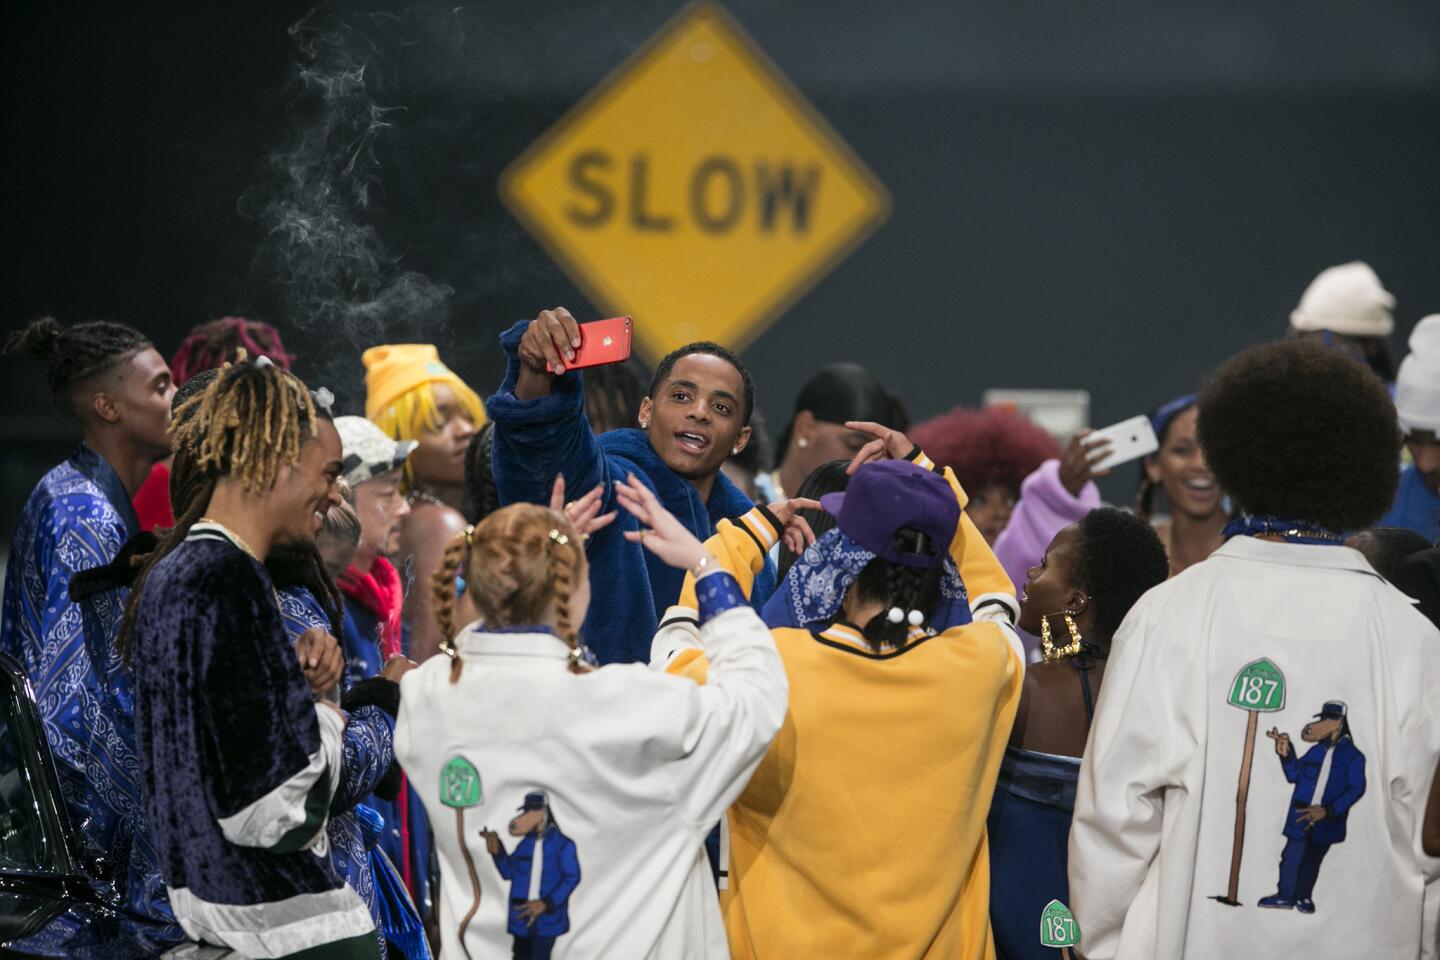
[500,3,890,360]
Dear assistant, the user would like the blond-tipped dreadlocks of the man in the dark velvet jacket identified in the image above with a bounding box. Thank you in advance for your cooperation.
[115,361,325,661]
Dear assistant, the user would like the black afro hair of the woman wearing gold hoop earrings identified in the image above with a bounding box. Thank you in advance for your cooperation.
[1074,507,1169,646]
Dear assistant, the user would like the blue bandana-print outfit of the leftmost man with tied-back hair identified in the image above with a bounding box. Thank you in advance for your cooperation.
[0,445,183,957]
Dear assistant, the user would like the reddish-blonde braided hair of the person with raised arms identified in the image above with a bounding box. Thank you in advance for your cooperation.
[431,504,589,684]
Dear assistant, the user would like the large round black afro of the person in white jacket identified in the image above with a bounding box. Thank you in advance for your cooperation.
[1197,340,1400,533]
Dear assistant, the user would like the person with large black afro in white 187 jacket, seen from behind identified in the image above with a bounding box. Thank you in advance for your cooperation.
[1068,340,1440,960]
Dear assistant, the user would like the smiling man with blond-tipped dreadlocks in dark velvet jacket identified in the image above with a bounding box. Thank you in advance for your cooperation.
[120,360,379,960]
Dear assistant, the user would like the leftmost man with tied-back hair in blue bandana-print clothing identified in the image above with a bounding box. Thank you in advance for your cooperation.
[0,317,180,956]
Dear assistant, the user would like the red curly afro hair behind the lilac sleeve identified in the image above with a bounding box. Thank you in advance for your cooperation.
[910,407,1060,494]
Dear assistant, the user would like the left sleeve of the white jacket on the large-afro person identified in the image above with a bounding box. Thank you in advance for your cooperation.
[1068,599,1175,960]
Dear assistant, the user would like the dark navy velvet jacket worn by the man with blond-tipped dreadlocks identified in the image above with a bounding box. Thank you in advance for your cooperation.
[132,541,365,946]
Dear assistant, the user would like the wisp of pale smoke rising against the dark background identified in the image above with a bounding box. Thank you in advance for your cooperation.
[240,6,454,407]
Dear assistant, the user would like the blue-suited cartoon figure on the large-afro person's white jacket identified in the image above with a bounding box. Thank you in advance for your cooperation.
[1259,699,1365,914]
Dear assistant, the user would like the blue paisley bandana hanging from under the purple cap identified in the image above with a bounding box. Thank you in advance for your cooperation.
[760,527,972,633]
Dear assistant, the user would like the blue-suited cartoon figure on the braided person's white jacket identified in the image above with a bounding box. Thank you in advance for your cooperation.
[480,790,580,960]
